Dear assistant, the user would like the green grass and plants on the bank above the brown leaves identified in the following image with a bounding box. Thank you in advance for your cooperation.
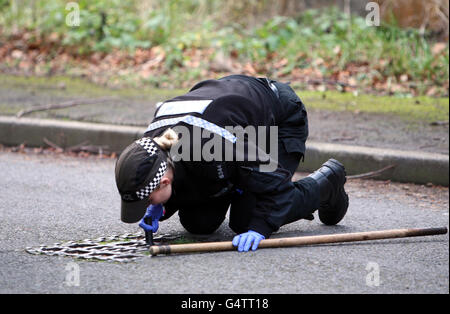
[0,0,449,95]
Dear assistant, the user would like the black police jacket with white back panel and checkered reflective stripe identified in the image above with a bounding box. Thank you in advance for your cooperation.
[145,75,294,238]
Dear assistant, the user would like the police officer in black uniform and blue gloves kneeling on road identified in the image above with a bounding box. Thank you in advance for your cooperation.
[115,75,348,251]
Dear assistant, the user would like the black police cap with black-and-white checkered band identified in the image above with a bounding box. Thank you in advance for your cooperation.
[115,137,168,223]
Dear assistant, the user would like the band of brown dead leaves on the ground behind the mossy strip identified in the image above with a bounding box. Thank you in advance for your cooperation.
[0,32,449,96]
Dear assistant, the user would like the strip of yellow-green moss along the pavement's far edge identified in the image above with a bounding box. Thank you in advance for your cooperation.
[0,75,449,122]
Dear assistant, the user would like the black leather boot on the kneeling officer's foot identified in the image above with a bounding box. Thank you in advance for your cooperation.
[309,159,348,225]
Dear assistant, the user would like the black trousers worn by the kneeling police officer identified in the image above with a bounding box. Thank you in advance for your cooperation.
[178,81,319,234]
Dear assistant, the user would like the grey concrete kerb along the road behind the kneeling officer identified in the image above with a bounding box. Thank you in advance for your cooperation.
[0,116,449,186]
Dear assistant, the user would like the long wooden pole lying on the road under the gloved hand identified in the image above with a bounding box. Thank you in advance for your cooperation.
[150,227,447,256]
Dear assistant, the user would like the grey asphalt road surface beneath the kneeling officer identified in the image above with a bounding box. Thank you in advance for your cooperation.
[0,150,449,294]
